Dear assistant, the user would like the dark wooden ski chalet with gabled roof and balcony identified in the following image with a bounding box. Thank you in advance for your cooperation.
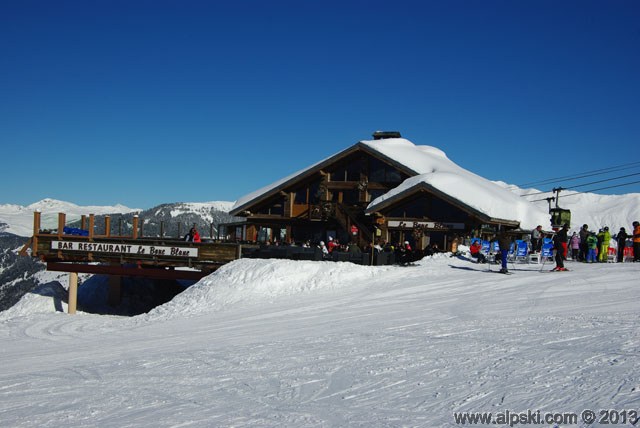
[228,132,532,249]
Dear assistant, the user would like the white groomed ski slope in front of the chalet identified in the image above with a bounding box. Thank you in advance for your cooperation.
[0,254,640,428]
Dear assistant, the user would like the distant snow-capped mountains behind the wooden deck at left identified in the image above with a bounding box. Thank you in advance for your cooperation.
[0,199,237,311]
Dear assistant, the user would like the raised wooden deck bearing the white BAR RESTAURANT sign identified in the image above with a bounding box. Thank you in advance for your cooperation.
[20,212,242,313]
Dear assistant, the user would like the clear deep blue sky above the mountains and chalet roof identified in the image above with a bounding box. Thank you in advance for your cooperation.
[0,0,640,208]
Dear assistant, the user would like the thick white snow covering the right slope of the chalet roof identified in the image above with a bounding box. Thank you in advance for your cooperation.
[361,138,549,228]
